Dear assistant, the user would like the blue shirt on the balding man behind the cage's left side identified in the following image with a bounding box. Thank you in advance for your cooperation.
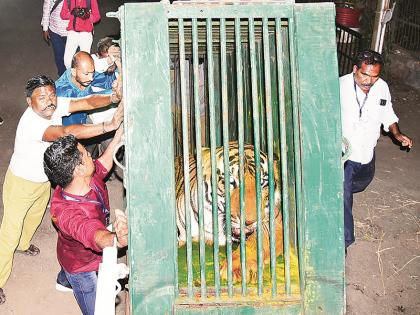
[55,69,116,126]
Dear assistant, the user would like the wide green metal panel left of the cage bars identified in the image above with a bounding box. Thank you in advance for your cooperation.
[120,4,176,314]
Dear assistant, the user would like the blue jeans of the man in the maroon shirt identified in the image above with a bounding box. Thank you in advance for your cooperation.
[59,270,98,315]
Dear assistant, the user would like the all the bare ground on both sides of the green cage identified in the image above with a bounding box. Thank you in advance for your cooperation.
[0,0,420,315]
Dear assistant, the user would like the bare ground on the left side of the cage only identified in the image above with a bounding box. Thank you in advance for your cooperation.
[0,0,124,315]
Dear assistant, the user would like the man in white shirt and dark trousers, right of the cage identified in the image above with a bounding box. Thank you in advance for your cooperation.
[340,50,413,252]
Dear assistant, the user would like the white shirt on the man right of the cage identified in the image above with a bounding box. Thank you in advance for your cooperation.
[340,73,398,164]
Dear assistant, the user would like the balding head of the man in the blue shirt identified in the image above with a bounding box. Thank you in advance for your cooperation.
[71,51,95,90]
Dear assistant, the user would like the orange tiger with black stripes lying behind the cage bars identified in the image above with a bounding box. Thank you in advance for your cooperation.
[175,141,283,282]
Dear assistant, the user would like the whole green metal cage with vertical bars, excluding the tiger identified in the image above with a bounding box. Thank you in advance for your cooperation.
[118,3,345,314]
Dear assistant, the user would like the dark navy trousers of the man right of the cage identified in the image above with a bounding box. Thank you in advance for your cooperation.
[344,155,375,248]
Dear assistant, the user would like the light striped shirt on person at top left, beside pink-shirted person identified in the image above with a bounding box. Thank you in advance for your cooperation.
[41,0,69,36]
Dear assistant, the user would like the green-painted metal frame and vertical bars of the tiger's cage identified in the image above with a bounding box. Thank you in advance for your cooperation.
[120,3,345,314]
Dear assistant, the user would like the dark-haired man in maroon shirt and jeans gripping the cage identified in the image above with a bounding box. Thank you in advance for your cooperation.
[44,126,128,315]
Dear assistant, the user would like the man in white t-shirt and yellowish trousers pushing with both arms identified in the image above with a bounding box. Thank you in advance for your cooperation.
[0,75,123,304]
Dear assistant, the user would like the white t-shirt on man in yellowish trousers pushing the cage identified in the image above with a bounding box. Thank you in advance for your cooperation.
[9,97,71,183]
